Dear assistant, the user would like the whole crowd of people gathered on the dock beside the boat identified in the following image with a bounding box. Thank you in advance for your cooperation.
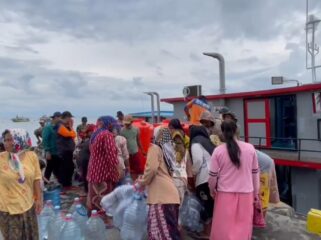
[0,97,278,240]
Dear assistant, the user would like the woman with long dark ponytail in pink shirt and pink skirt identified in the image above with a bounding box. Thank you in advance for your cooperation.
[209,121,260,240]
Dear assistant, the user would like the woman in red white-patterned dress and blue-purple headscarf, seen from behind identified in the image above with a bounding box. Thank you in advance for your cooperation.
[87,116,119,215]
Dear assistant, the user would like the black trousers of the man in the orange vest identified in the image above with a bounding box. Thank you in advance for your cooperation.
[58,151,75,187]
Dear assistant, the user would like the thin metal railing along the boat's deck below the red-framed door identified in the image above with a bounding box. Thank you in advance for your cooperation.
[240,136,321,161]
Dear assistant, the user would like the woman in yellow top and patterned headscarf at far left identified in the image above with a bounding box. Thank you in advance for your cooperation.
[0,130,43,240]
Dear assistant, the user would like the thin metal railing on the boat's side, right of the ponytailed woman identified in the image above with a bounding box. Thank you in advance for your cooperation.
[240,136,321,161]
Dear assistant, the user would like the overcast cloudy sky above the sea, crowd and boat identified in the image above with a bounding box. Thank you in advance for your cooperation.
[0,0,321,117]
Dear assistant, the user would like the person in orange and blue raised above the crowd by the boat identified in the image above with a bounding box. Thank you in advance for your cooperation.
[184,95,211,125]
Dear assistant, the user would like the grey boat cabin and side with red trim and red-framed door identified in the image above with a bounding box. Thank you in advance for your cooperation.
[162,83,321,214]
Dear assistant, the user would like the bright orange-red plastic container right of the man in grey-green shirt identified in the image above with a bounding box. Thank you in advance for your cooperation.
[133,119,154,170]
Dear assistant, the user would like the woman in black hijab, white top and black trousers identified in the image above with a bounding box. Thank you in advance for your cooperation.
[190,126,215,237]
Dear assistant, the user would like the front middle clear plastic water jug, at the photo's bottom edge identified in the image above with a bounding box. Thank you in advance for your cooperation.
[59,213,82,240]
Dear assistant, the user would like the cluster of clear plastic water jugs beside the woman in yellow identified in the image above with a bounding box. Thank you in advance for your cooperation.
[38,198,107,240]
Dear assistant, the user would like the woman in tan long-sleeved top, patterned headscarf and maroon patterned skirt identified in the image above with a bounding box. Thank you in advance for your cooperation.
[138,128,181,240]
